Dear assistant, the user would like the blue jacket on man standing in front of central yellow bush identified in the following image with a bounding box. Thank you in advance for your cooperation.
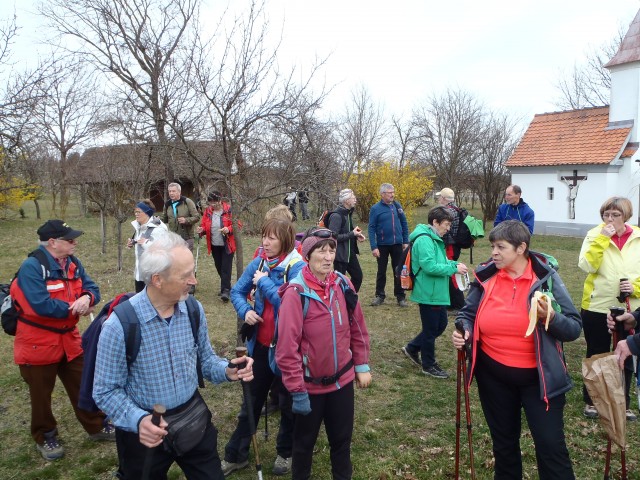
[369,200,409,250]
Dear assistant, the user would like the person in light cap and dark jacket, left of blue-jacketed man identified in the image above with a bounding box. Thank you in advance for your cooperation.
[328,188,366,292]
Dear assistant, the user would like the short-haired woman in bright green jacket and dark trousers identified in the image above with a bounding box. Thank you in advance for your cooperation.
[402,207,467,378]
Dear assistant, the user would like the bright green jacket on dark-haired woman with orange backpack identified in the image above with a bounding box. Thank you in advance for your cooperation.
[409,223,458,305]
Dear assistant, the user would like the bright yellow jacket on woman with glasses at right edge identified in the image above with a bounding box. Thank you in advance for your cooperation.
[578,223,640,313]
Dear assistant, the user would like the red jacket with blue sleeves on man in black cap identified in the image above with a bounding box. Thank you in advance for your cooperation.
[10,247,100,365]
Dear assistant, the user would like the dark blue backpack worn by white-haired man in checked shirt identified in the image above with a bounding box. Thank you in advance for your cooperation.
[78,292,204,412]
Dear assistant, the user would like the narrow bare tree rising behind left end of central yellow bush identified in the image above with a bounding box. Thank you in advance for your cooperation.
[337,86,386,182]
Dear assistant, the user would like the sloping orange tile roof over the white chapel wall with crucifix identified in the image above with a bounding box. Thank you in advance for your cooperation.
[506,107,631,167]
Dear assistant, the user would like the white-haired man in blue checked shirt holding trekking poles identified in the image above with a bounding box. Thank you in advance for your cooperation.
[93,232,253,480]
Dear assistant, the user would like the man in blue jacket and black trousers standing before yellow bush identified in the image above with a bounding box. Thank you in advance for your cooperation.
[369,183,409,307]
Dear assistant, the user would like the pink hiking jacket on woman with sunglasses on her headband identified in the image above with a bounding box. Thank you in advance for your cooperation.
[276,273,369,395]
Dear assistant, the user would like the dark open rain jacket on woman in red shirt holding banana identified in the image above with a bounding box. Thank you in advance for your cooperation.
[456,251,582,403]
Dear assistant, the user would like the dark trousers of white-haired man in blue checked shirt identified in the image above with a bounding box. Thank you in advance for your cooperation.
[116,422,224,480]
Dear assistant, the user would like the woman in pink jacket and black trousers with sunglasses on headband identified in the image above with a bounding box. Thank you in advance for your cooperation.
[276,227,371,480]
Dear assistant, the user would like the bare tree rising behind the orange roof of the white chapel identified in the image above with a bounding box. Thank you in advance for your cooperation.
[555,28,625,110]
